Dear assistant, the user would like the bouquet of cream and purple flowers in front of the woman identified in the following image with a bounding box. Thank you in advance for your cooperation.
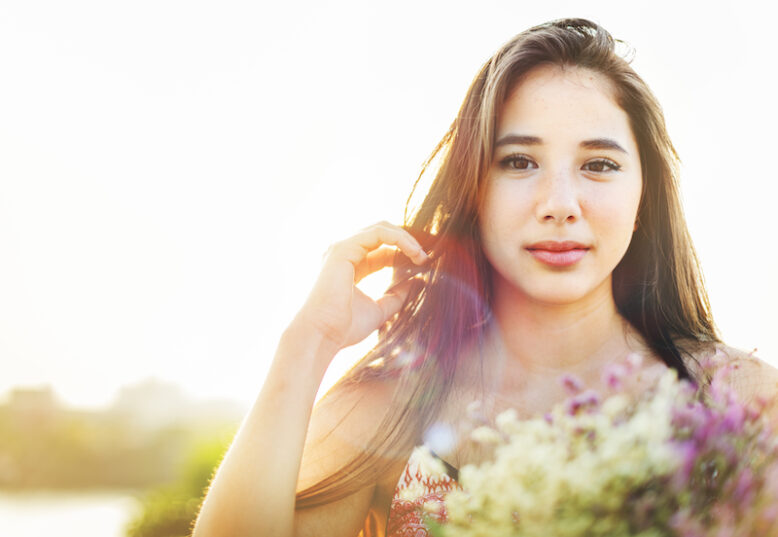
[425,356,778,537]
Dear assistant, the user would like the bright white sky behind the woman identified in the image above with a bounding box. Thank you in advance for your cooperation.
[0,0,778,405]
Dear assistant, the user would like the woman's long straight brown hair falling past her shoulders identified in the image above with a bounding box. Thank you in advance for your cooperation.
[297,19,721,508]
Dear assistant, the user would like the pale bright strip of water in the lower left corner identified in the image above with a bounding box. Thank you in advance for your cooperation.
[0,492,139,537]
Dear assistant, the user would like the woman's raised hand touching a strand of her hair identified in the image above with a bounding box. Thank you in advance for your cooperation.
[297,222,429,350]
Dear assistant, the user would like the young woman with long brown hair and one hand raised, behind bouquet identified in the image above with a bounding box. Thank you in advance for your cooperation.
[189,19,778,537]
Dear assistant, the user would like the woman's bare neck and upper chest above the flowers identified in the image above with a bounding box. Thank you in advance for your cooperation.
[442,278,665,467]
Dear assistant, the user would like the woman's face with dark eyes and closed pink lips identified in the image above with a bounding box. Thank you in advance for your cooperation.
[479,66,642,304]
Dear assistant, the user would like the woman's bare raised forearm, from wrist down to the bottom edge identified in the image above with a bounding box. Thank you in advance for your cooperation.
[193,322,337,537]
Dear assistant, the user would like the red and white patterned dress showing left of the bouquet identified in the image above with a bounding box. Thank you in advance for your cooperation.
[386,450,461,537]
